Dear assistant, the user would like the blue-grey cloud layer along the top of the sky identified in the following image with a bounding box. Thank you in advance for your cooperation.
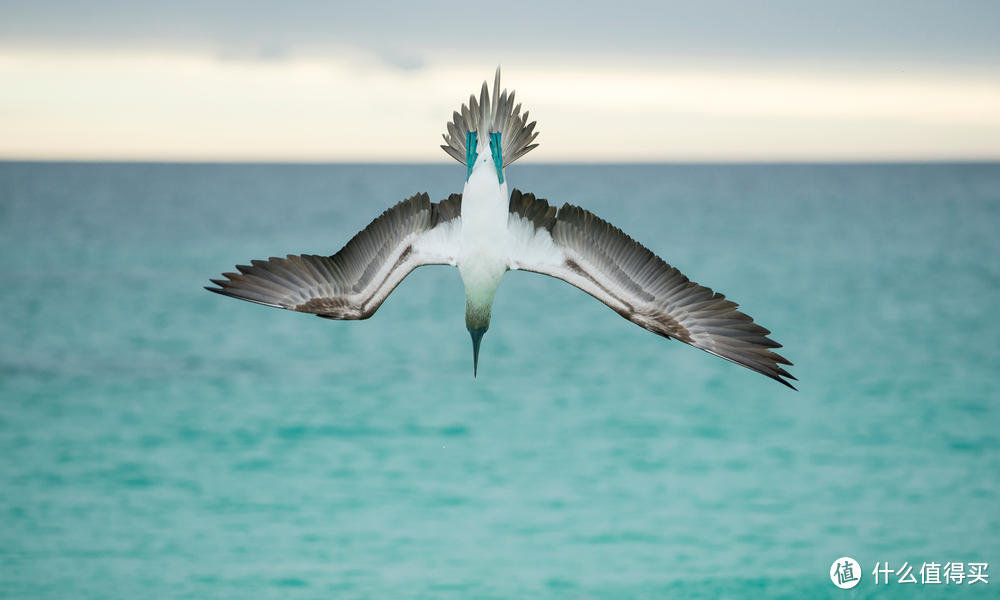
[0,0,1000,70]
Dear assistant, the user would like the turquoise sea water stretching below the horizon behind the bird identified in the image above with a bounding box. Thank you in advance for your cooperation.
[0,163,1000,598]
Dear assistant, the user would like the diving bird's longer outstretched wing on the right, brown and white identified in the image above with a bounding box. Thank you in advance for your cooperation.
[508,190,795,389]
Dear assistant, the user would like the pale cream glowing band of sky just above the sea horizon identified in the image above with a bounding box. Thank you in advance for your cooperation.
[0,47,1000,162]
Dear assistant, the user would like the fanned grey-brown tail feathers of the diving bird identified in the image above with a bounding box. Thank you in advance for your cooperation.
[441,67,538,167]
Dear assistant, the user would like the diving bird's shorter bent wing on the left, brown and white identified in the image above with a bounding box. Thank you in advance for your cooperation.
[205,194,462,319]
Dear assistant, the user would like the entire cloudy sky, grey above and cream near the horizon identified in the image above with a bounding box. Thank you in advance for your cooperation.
[0,0,1000,163]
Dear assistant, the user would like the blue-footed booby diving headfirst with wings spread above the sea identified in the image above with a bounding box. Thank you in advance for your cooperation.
[205,67,795,389]
